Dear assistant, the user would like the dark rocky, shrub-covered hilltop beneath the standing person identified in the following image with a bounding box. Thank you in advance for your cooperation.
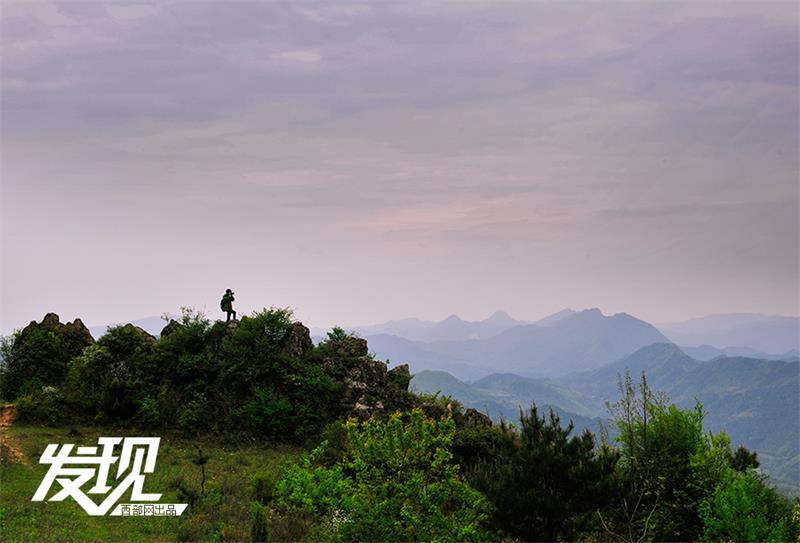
[2,309,413,439]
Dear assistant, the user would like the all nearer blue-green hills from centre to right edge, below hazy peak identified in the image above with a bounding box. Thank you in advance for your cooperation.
[411,343,800,495]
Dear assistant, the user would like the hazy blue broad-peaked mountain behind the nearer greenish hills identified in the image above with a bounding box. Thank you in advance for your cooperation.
[365,309,669,379]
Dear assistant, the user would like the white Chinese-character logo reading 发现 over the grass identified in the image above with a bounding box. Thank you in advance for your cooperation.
[32,437,187,516]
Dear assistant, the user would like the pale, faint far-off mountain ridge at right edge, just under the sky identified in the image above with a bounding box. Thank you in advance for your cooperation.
[658,313,800,353]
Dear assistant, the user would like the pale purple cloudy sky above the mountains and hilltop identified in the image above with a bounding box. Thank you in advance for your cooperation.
[0,0,799,333]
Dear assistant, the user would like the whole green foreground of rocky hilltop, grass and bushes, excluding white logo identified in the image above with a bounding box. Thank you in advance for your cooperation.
[0,309,800,542]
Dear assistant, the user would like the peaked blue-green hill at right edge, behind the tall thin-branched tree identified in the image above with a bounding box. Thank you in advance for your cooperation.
[558,344,800,494]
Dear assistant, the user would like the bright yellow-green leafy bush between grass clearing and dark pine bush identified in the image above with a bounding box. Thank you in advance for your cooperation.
[276,409,489,541]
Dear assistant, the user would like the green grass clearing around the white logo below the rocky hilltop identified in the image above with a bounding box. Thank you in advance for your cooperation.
[0,425,301,542]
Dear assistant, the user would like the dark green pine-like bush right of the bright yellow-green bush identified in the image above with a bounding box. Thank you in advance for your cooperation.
[460,404,617,541]
